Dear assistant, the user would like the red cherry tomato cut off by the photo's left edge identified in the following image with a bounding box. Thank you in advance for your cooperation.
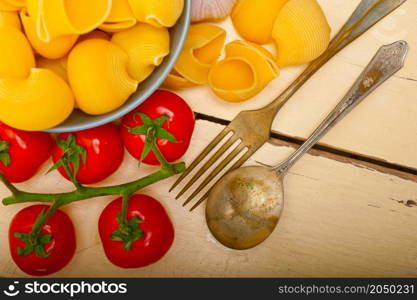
[0,122,53,183]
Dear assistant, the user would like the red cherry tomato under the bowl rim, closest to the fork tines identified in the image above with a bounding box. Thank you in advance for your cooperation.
[122,90,195,165]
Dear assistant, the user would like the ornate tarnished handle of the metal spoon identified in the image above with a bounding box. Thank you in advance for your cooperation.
[274,41,408,173]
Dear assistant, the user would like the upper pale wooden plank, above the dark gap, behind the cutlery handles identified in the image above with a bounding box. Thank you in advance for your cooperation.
[170,0,417,169]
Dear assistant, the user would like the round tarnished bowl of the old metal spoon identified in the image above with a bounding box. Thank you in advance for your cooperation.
[206,167,284,250]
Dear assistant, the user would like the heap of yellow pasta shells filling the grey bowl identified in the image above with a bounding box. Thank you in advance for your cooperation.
[0,0,184,130]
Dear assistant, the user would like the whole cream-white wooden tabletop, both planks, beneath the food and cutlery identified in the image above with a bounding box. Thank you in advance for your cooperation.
[0,0,417,277]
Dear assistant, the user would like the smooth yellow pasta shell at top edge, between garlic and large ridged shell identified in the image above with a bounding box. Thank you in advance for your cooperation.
[232,0,288,44]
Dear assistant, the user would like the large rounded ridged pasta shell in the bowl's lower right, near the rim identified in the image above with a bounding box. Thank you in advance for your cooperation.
[68,39,138,115]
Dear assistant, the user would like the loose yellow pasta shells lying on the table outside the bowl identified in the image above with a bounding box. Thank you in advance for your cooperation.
[165,0,331,102]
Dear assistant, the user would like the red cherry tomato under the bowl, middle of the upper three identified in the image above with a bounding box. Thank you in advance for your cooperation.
[52,123,124,184]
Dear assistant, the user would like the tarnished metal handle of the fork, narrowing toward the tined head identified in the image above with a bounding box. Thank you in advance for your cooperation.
[263,0,407,116]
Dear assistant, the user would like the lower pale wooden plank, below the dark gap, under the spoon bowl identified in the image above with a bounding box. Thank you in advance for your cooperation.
[0,121,417,277]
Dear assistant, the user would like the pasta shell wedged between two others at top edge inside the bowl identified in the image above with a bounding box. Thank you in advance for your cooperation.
[100,0,137,32]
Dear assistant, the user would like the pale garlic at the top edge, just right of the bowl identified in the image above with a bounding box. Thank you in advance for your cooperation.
[191,0,236,22]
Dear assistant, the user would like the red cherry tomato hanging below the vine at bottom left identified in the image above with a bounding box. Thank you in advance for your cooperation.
[9,205,76,276]
